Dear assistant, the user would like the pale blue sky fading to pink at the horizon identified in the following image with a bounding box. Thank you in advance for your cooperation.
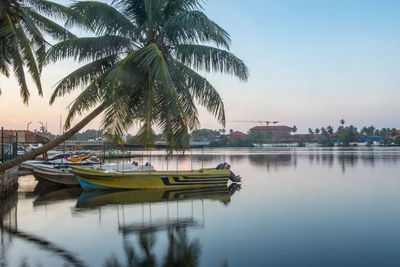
[0,0,400,134]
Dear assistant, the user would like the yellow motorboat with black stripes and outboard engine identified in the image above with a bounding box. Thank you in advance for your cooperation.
[71,163,240,190]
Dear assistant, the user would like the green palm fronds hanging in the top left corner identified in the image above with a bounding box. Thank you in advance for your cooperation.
[0,0,74,104]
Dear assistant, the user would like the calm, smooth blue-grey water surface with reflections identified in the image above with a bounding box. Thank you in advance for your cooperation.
[0,148,400,266]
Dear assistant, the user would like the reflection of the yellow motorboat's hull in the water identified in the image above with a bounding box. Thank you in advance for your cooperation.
[76,183,241,209]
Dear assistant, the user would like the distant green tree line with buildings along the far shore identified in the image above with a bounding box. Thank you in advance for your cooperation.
[38,119,400,147]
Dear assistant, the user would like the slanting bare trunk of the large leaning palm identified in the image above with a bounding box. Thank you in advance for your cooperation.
[0,105,105,172]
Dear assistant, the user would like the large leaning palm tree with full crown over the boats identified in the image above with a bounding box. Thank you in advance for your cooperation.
[0,0,248,171]
